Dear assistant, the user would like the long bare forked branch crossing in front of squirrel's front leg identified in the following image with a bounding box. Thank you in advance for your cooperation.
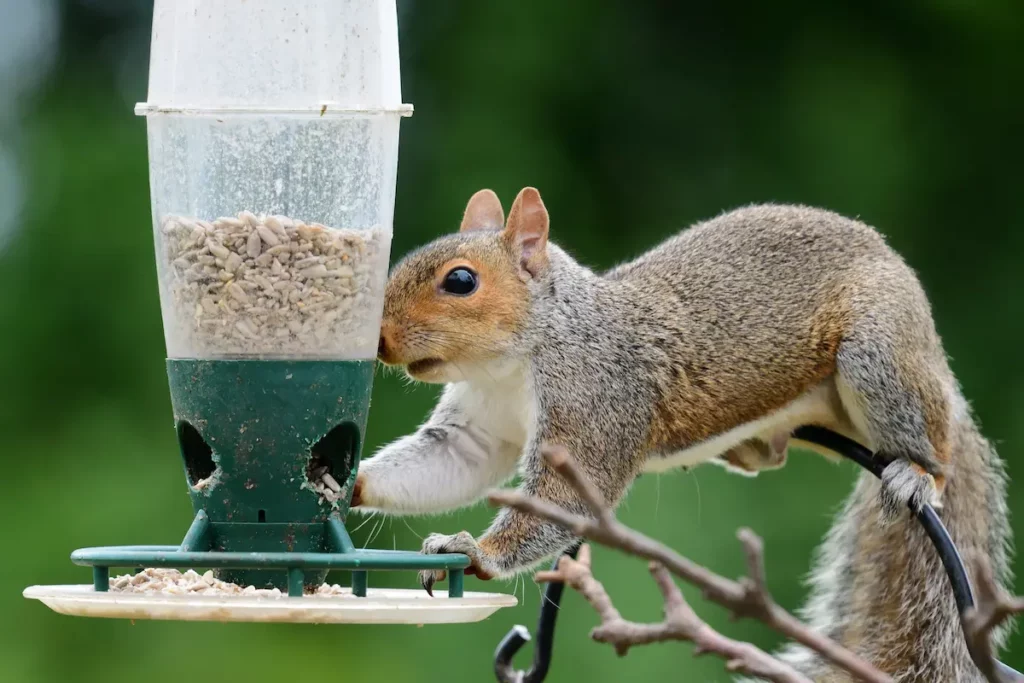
[489,447,893,683]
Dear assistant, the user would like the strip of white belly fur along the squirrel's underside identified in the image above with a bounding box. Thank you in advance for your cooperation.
[644,378,865,472]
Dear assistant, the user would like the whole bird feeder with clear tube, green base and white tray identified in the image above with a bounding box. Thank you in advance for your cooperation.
[26,0,515,624]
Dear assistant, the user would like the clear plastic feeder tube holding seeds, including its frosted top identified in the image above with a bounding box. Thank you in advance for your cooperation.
[136,0,412,359]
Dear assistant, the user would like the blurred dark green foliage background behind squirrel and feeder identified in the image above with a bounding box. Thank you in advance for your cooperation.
[0,0,1024,683]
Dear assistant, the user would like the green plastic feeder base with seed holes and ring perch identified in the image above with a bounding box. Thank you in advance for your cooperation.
[66,359,470,597]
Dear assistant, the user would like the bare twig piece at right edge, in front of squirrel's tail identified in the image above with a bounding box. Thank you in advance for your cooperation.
[962,557,1024,683]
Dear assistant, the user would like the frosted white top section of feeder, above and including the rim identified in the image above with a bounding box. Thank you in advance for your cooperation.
[136,0,412,116]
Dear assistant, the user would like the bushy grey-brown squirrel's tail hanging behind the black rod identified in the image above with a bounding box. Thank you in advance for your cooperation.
[780,392,1011,683]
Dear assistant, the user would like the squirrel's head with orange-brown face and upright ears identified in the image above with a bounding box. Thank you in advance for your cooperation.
[377,187,549,382]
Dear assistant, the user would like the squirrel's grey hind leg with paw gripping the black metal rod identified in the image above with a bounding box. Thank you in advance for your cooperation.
[837,334,949,520]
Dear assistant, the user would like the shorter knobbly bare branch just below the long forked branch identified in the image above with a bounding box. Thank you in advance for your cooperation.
[537,545,812,683]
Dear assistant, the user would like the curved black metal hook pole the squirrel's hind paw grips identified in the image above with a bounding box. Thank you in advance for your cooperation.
[495,426,1024,683]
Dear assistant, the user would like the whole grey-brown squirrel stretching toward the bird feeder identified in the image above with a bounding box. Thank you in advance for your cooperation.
[352,187,1010,683]
